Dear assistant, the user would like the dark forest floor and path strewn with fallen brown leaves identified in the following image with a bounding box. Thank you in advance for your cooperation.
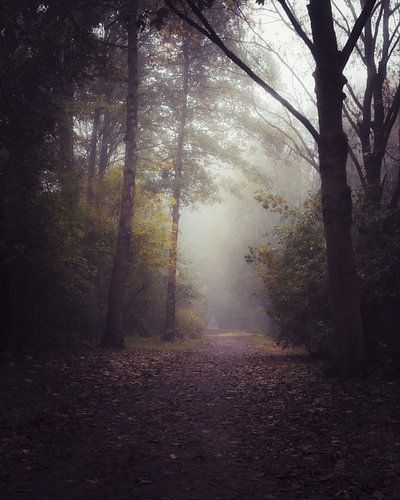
[0,335,400,500]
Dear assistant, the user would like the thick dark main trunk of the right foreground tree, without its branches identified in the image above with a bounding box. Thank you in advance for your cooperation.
[309,0,365,377]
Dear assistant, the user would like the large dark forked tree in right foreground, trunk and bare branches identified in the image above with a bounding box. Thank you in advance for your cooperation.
[156,0,382,376]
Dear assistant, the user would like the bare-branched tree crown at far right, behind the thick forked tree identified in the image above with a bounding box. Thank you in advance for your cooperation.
[337,0,400,208]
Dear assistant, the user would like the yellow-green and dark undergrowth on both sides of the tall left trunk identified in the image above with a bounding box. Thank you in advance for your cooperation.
[0,159,174,345]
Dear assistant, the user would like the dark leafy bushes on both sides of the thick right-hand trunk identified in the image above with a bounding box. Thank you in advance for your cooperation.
[252,192,400,359]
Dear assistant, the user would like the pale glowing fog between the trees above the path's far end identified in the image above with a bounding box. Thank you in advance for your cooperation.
[180,143,317,334]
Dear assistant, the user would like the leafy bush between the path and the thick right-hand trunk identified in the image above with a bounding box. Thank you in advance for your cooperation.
[247,197,331,353]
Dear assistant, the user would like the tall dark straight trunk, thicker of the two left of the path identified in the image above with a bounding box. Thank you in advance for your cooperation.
[102,0,138,348]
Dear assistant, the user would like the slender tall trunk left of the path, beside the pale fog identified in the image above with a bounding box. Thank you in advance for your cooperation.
[164,42,189,340]
